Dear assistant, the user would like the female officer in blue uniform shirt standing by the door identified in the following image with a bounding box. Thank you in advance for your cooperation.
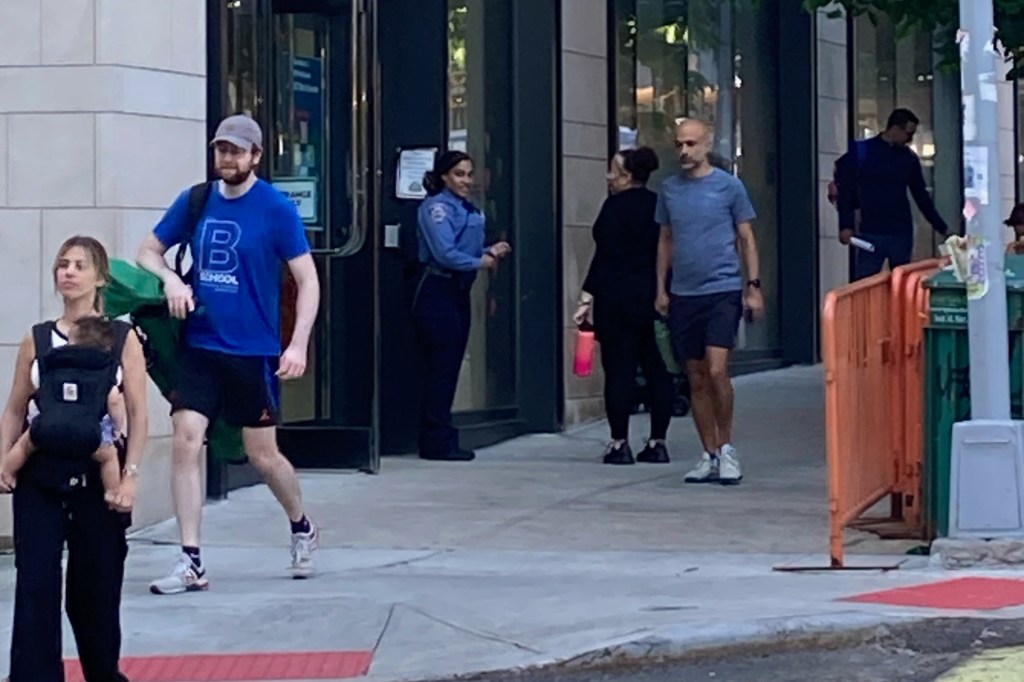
[413,151,511,462]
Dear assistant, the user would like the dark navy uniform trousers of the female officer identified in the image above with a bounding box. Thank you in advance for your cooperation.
[413,274,471,456]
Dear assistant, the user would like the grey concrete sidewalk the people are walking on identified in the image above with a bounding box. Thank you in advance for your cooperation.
[0,368,1024,682]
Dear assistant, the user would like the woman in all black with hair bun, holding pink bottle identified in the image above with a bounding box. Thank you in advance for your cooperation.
[574,146,672,464]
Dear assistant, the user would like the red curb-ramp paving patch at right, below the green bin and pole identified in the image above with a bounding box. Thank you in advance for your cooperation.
[843,578,1024,611]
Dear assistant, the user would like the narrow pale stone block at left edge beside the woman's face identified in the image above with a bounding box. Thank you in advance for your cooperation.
[0,209,42,342]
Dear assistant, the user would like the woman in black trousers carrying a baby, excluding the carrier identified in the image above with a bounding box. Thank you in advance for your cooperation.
[0,237,148,682]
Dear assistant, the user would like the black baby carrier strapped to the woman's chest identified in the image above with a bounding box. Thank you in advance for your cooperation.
[30,321,131,459]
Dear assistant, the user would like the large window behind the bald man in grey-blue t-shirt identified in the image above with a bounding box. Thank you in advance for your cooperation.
[612,0,778,350]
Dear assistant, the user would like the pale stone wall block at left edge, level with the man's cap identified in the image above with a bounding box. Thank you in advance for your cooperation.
[7,114,96,208]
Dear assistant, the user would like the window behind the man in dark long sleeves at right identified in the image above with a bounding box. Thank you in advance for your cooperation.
[854,15,936,259]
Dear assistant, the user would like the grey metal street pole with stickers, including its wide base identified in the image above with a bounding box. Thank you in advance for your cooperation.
[932,0,1024,540]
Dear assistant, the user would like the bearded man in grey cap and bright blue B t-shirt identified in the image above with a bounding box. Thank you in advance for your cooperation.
[138,116,319,594]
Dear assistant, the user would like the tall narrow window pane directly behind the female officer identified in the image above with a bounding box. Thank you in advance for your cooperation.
[447,0,516,412]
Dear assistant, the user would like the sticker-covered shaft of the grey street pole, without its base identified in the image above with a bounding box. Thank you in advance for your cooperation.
[958,0,1010,420]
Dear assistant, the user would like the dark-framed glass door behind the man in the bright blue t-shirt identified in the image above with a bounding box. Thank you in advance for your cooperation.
[220,0,379,471]
